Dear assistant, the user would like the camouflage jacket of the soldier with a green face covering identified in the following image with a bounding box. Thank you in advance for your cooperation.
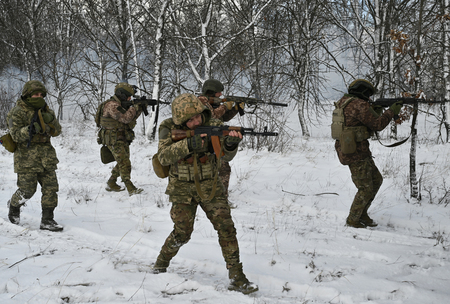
[7,99,61,173]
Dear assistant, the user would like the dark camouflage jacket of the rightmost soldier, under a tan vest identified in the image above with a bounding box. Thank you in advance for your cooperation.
[335,94,394,165]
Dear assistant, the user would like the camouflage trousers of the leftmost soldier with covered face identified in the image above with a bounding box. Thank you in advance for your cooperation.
[10,170,59,209]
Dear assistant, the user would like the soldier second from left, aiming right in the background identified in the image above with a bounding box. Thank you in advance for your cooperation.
[97,82,143,196]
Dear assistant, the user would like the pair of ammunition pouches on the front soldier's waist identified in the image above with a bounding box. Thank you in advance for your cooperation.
[170,154,216,182]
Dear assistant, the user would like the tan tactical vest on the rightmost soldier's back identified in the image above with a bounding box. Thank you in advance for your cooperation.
[331,97,370,154]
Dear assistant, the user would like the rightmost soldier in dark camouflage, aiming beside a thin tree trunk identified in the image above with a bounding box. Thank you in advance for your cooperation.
[332,79,402,228]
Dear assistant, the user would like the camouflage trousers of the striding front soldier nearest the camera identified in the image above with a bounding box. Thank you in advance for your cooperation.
[157,197,239,268]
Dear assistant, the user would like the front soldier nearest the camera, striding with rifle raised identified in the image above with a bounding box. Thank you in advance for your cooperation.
[153,93,258,294]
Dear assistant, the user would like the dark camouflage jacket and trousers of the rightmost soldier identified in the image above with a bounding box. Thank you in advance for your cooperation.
[335,94,394,225]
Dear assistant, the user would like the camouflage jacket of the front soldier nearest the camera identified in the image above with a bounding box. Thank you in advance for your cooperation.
[158,118,237,203]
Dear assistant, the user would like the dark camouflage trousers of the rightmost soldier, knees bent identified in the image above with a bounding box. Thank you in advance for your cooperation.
[349,158,383,221]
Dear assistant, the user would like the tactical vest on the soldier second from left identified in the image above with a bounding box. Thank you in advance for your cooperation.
[95,96,135,146]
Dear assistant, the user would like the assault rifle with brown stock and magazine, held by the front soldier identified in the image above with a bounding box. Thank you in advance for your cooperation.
[171,126,278,158]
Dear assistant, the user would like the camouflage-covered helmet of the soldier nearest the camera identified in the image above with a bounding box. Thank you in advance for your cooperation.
[172,93,211,125]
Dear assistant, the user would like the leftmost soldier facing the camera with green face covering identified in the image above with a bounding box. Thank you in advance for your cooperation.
[6,80,63,231]
